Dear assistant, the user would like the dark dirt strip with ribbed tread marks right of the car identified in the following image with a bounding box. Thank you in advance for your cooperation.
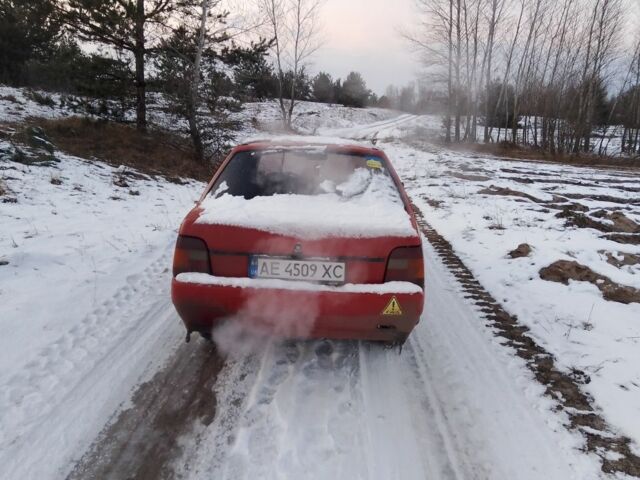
[413,205,640,477]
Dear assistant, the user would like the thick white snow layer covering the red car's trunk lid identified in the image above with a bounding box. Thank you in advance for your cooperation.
[196,170,417,239]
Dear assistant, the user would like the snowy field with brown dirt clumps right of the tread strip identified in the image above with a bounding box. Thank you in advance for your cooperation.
[404,147,640,440]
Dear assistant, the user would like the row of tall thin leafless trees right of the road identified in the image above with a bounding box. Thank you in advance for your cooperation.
[407,0,640,154]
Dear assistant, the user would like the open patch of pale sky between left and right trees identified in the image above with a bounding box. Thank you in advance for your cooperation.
[311,0,418,94]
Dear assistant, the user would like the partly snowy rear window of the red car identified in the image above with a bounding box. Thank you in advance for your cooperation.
[210,147,395,199]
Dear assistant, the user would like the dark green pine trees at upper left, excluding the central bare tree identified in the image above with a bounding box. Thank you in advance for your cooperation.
[0,0,270,161]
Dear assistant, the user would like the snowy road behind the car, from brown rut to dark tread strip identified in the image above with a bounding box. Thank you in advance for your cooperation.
[61,236,598,480]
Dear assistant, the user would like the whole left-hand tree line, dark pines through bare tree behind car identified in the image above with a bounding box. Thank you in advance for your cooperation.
[0,0,375,161]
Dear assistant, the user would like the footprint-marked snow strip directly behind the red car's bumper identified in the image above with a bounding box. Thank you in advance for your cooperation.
[173,340,471,480]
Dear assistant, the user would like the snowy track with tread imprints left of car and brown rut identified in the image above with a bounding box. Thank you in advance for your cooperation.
[0,245,178,478]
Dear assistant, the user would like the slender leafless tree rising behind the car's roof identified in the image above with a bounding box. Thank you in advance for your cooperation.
[259,0,323,129]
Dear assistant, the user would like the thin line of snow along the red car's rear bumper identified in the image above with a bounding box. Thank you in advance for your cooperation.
[176,273,422,295]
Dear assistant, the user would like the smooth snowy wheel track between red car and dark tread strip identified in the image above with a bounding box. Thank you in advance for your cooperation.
[407,245,592,480]
